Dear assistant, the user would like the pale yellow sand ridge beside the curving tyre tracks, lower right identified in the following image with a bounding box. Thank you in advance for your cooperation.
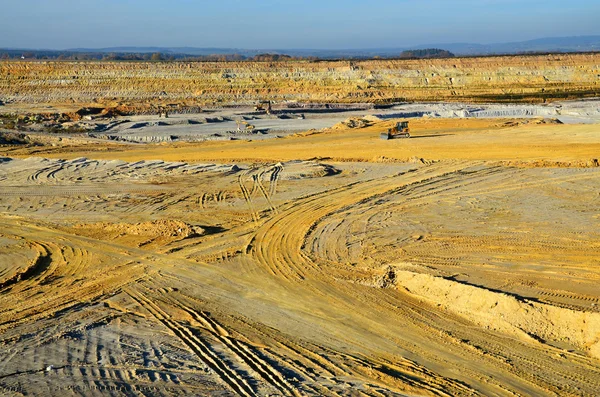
[378,268,600,358]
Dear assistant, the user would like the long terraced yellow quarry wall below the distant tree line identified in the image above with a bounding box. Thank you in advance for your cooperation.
[0,54,600,104]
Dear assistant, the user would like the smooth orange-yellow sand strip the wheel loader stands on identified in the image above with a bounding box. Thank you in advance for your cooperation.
[4,118,600,165]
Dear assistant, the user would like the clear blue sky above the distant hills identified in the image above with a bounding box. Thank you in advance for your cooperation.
[0,0,600,49]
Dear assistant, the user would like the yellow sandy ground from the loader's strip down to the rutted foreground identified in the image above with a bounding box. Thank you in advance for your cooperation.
[0,118,600,396]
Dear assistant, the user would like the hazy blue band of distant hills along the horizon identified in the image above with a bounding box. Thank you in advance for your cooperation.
[0,36,600,59]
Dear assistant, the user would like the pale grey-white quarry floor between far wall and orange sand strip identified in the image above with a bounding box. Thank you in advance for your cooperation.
[19,99,600,143]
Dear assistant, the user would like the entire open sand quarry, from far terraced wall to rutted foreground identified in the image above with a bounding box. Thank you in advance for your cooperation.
[0,55,600,397]
